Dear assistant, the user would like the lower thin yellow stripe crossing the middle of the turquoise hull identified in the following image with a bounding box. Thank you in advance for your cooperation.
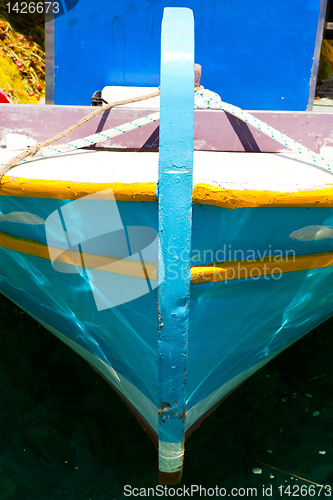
[0,232,333,284]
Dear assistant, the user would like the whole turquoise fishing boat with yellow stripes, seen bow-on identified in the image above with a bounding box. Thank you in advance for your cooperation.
[0,8,333,484]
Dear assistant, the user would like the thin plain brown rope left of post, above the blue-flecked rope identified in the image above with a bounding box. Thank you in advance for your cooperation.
[0,90,160,181]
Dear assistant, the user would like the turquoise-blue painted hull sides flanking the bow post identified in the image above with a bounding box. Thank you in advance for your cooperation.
[0,196,333,442]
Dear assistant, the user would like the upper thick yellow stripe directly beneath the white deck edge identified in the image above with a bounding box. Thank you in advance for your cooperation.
[0,175,333,208]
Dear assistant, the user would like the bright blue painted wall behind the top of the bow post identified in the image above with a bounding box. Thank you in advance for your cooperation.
[55,0,325,110]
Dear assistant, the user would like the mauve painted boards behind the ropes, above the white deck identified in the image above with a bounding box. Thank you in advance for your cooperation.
[0,104,333,152]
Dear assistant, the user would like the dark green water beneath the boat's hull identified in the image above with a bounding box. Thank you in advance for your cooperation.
[0,292,333,500]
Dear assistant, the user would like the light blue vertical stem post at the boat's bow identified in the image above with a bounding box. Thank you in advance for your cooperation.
[158,8,194,484]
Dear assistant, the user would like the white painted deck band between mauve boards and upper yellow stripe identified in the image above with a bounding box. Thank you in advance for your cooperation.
[0,149,333,193]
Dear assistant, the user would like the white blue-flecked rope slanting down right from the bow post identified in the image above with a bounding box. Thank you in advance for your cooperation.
[194,89,333,173]
